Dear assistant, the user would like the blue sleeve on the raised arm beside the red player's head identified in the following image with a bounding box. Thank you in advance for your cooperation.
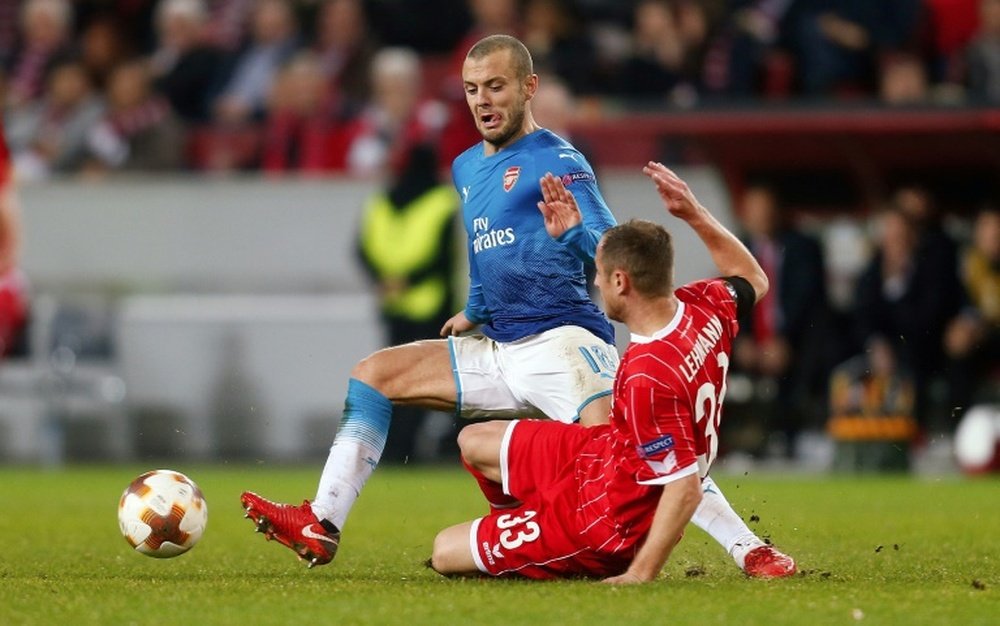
[546,153,617,264]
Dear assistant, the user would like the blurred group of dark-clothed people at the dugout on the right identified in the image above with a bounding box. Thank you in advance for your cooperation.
[727,184,1000,469]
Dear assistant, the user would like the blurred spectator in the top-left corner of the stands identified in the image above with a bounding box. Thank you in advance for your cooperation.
[6,0,73,108]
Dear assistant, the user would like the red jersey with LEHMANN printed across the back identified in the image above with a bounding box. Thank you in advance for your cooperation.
[577,279,739,540]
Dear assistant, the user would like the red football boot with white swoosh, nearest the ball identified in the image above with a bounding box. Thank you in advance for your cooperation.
[240,491,340,568]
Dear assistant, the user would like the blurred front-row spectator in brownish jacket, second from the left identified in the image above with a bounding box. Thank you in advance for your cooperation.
[87,61,184,174]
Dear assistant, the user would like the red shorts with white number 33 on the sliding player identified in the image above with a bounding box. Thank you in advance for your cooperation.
[469,420,635,578]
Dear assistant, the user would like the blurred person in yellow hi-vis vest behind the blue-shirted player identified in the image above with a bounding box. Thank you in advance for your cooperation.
[357,143,461,463]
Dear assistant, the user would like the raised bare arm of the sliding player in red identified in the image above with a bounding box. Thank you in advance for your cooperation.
[642,161,768,300]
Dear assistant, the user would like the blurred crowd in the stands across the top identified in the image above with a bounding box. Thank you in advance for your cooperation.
[0,0,1000,179]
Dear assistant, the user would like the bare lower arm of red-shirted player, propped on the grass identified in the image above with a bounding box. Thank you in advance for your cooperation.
[604,474,702,585]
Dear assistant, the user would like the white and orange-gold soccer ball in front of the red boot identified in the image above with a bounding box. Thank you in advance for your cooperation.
[118,470,208,559]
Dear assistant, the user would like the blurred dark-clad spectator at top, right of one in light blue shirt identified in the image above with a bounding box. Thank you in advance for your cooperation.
[313,0,378,118]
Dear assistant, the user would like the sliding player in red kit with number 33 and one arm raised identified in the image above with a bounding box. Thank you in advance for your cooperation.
[431,163,767,583]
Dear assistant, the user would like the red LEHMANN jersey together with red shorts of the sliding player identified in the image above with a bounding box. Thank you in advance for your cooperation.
[471,279,738,578]
